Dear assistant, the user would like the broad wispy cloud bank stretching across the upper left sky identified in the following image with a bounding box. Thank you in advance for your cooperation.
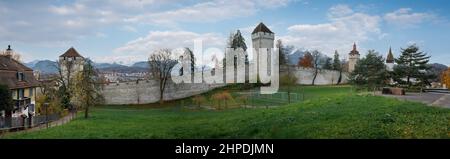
[0,0,291,45]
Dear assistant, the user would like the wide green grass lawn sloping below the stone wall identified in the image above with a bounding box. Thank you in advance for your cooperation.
[4,86,450,139]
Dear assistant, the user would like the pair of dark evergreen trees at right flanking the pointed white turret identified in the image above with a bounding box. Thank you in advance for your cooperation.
[350,45,434,90]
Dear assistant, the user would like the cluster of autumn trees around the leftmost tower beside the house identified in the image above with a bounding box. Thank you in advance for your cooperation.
[36,59,105,118]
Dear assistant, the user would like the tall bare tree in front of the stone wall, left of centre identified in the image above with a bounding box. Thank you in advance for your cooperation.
[148,49,176,103]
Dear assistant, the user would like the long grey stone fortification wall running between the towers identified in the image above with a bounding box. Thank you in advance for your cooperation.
[103,67,348,104]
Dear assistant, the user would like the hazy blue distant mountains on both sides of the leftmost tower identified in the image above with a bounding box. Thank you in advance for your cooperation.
[24,60,149,74]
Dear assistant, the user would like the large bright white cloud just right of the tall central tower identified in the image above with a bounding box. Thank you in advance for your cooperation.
[280,5,386,55]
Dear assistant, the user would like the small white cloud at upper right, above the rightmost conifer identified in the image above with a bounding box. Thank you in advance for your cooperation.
[384,8,437,27]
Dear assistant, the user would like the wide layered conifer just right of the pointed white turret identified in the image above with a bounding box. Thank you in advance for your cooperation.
[393,45,432,88]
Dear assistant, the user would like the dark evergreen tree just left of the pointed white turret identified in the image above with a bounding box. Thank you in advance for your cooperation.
[350,50,388,90]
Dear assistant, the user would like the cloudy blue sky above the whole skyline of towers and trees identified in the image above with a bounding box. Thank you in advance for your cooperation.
[0,0,450,65]
